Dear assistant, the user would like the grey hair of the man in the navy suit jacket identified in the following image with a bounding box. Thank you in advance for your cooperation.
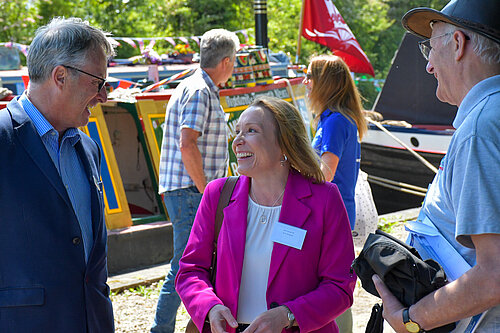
[26,17,115,83]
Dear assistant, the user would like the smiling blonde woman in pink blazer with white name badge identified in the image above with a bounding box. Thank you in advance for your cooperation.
[176,97,356,333]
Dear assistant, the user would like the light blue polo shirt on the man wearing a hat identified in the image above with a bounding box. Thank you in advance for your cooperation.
[423,75,500,266]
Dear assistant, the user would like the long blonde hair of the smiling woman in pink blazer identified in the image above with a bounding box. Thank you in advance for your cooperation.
[250,96,325,183]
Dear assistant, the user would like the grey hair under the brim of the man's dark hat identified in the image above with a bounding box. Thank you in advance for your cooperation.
[440,22,500,65]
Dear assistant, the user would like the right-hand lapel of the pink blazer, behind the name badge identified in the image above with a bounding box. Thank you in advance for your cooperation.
[267,170,312,289]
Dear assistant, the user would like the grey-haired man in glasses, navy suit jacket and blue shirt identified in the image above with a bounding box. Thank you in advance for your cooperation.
[0,18,114,333]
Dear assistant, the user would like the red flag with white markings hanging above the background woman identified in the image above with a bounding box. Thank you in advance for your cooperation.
[302,0,375,76]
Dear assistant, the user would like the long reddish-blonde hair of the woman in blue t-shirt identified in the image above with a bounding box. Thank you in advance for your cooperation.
[308,55,367,139]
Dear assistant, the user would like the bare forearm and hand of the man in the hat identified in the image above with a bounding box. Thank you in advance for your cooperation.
[373,234,500,333]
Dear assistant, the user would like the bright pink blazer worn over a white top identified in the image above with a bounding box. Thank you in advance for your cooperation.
[176,171,356,332]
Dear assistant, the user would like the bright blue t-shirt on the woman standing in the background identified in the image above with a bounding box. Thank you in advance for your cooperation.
[312,109,361,229]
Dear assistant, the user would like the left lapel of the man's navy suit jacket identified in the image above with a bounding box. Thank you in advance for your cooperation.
[7,99,73,209]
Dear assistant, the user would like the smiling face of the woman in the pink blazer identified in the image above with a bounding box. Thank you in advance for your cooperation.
[233,106,282,177]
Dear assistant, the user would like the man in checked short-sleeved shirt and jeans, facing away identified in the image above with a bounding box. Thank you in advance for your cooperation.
[151,29,239,333]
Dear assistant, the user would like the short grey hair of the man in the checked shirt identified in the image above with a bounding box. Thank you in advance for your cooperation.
[200,29,240,68]
